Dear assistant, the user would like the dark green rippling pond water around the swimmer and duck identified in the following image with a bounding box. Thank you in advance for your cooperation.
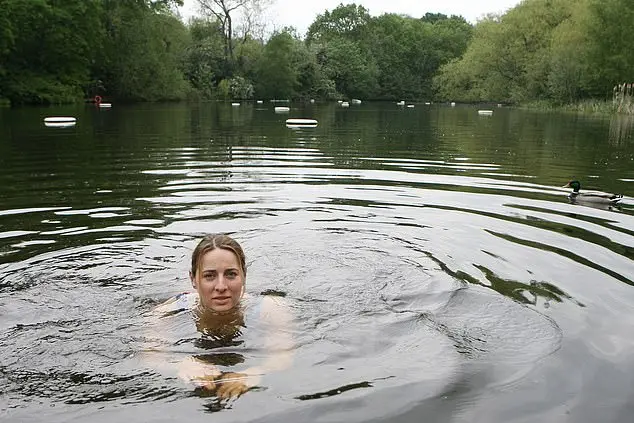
[0,103,634,423]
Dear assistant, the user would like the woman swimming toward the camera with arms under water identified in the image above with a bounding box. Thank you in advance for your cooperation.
[156,234,293,398]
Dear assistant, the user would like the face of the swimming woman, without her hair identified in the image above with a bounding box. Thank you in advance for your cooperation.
[190,248,244,312]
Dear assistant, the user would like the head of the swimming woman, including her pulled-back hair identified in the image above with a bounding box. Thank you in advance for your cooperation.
[189,235,247,312]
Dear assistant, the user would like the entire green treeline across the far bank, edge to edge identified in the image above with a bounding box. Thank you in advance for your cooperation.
[0,0,634,104]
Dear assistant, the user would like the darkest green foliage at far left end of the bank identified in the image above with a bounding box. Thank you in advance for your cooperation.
[0,0,103,103]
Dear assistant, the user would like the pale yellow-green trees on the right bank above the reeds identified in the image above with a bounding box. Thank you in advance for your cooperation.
[435,0,634,104]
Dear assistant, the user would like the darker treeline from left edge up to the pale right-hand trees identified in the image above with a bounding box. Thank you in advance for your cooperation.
[0,0,472,104]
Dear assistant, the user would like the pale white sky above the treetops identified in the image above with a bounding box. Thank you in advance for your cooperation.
[181,0,520,35]
